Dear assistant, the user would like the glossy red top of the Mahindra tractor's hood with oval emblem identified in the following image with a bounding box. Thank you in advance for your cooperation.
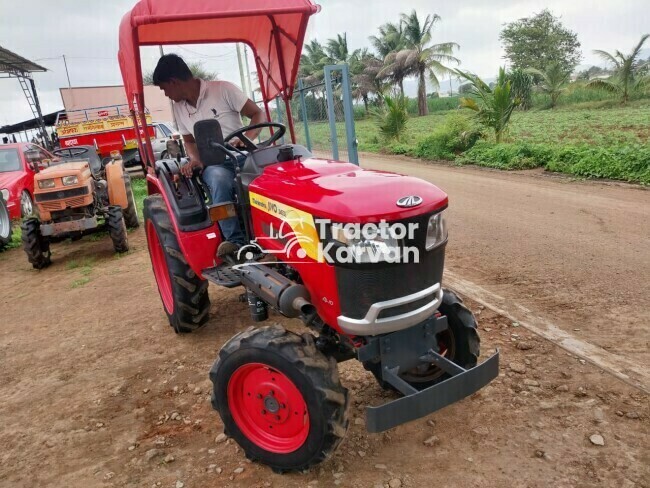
[249,158,447,223]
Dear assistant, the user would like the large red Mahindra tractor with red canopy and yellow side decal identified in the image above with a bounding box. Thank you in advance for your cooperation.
[119,0,499,472]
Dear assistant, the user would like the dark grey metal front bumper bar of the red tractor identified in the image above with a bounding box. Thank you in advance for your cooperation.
[366,350,499,432]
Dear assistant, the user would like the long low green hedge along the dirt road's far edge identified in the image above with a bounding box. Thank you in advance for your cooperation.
[458,141,650,185]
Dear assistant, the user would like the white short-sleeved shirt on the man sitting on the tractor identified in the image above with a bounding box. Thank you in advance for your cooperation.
[174,80,248,137]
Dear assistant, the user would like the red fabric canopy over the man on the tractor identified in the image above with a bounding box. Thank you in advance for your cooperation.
[118,0,320,166]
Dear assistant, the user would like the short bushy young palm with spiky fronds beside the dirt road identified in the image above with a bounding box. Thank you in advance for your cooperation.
[456,68,519,143]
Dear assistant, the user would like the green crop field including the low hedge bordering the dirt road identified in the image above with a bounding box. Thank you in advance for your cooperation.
[297,99,650,184]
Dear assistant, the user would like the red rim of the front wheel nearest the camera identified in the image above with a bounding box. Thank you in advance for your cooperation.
[228,363,309,454]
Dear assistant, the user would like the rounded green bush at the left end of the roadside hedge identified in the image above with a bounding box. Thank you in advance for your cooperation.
[414,112,482,159]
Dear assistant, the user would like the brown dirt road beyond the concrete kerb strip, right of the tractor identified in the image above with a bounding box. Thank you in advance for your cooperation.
[361,154,650,376]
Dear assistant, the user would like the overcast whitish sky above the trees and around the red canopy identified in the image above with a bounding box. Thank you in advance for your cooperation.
[0,0,650,126]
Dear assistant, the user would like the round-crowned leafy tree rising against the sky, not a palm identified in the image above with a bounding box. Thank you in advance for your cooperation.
[499,9,582,72]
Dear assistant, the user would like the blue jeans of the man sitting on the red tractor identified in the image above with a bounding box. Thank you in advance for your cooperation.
[203,155,246,246]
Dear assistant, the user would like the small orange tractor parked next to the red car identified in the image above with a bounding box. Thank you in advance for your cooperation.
[21,146,139,269]
